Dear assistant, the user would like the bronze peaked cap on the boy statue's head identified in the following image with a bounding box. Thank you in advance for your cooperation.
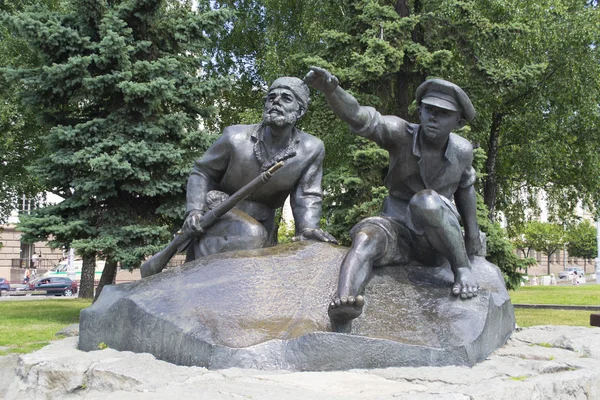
[416,79,475,121]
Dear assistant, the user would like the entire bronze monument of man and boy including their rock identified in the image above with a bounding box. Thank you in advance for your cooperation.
[85,74,515,371]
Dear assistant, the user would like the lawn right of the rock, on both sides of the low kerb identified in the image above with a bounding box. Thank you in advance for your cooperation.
[509,284,600,327]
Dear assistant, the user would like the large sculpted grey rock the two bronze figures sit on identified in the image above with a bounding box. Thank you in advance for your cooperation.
[79,242,514,370]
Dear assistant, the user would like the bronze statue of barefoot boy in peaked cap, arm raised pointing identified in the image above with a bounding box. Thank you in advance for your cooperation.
[304,67,479,331]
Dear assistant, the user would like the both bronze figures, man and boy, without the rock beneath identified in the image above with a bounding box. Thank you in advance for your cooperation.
[142,67,480,332]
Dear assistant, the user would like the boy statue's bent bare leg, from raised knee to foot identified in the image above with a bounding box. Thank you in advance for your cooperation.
[410,190,479,299]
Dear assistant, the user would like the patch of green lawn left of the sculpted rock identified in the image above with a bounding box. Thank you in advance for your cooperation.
[0,299,91,355]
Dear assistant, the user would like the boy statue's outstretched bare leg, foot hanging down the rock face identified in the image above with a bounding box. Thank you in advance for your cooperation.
[329,225,386,332]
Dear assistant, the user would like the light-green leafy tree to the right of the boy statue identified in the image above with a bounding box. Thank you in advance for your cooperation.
[441,0,600,224]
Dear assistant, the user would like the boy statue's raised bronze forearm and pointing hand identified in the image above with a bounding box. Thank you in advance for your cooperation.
[304,67,369,131]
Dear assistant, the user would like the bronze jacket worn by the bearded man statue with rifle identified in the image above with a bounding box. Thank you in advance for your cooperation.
[187,124,325,237]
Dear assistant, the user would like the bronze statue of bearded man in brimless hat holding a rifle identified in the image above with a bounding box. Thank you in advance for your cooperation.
[137,77,337,277]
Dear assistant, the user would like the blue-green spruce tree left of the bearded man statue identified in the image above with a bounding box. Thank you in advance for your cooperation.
[3,0,231,297]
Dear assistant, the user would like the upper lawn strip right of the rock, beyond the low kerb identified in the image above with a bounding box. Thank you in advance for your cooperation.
[510,284,600,306]
